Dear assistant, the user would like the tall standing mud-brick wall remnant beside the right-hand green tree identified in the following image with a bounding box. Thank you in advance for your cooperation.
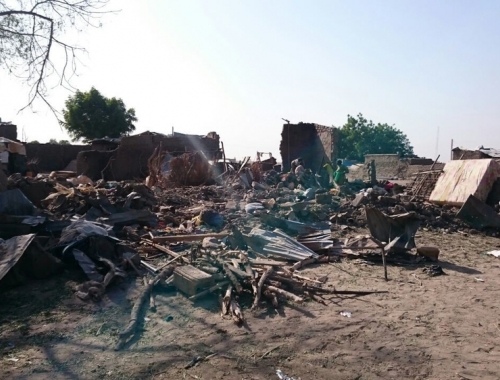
[280,123,339,173]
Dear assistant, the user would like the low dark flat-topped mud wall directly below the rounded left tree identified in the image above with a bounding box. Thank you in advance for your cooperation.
[26,143,89,172]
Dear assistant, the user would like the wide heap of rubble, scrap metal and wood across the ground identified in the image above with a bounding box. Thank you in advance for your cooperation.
[0,147,500,349]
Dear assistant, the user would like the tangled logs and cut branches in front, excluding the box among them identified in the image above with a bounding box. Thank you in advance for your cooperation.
[116,239,385,349]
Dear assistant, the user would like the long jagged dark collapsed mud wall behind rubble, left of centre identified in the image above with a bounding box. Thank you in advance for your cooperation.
[77,132,221,181]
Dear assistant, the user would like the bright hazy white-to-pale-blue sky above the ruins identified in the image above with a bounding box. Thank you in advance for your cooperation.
[0,0,500,159]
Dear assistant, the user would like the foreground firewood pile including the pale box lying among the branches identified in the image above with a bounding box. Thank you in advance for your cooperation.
[112,234,383,350]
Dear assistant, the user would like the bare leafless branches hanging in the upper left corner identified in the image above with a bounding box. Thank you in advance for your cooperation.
[0,0,110,114]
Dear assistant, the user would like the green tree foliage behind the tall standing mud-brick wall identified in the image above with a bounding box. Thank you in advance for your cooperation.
[339,114,414,161]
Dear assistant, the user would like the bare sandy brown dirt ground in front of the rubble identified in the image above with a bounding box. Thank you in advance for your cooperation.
[0,232,500,380]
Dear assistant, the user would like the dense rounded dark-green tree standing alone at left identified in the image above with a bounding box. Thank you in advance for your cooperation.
[61,87,137,142]
